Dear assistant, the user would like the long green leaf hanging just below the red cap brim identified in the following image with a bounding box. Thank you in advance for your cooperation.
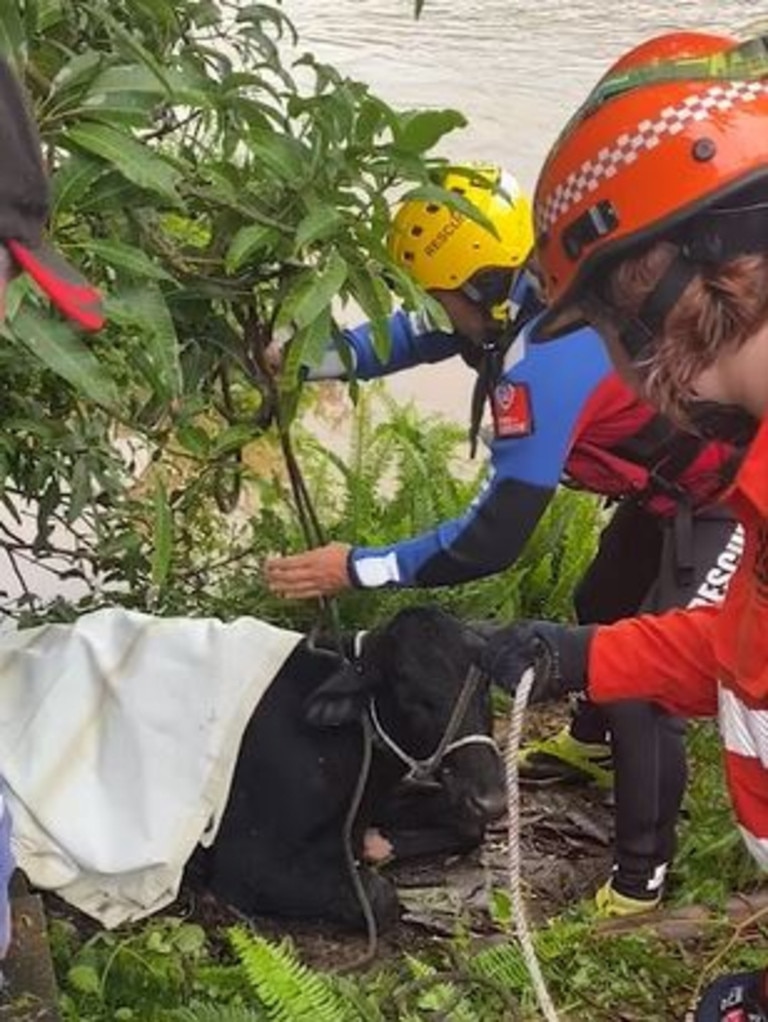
[4,308,118,408]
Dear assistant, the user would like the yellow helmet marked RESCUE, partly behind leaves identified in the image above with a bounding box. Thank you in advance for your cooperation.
[389,164,534,301]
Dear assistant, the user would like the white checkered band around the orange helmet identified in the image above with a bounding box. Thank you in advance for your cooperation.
[536,82,768,233]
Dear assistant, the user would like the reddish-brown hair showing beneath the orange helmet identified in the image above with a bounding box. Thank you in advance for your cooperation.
[605,241,768,419]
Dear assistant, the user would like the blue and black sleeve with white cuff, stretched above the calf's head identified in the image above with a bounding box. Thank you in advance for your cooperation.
[348,322,611,588]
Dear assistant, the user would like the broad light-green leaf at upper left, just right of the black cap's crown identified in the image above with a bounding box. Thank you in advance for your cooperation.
[63,122,181,204]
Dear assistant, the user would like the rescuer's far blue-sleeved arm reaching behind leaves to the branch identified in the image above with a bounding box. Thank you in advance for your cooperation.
[307,310,462,380]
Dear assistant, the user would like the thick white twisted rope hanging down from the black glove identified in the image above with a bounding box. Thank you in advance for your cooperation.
[506,667,559,1022]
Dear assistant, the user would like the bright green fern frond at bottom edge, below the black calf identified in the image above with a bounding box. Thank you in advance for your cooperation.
[229,927,352,1022]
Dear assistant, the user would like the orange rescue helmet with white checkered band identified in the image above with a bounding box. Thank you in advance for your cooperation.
[534,32,768,340]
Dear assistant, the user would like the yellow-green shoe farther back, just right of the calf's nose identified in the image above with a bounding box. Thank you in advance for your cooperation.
[517,727,614,789]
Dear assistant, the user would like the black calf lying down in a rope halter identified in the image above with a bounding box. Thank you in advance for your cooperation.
[196,608,504,927]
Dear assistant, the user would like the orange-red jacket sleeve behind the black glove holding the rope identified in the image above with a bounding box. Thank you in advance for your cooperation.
[588,607,720,716]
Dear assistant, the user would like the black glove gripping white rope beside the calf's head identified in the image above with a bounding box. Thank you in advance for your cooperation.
[484,621,594,702]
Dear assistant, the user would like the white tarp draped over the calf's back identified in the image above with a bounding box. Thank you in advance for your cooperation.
[0,608,302,926]
